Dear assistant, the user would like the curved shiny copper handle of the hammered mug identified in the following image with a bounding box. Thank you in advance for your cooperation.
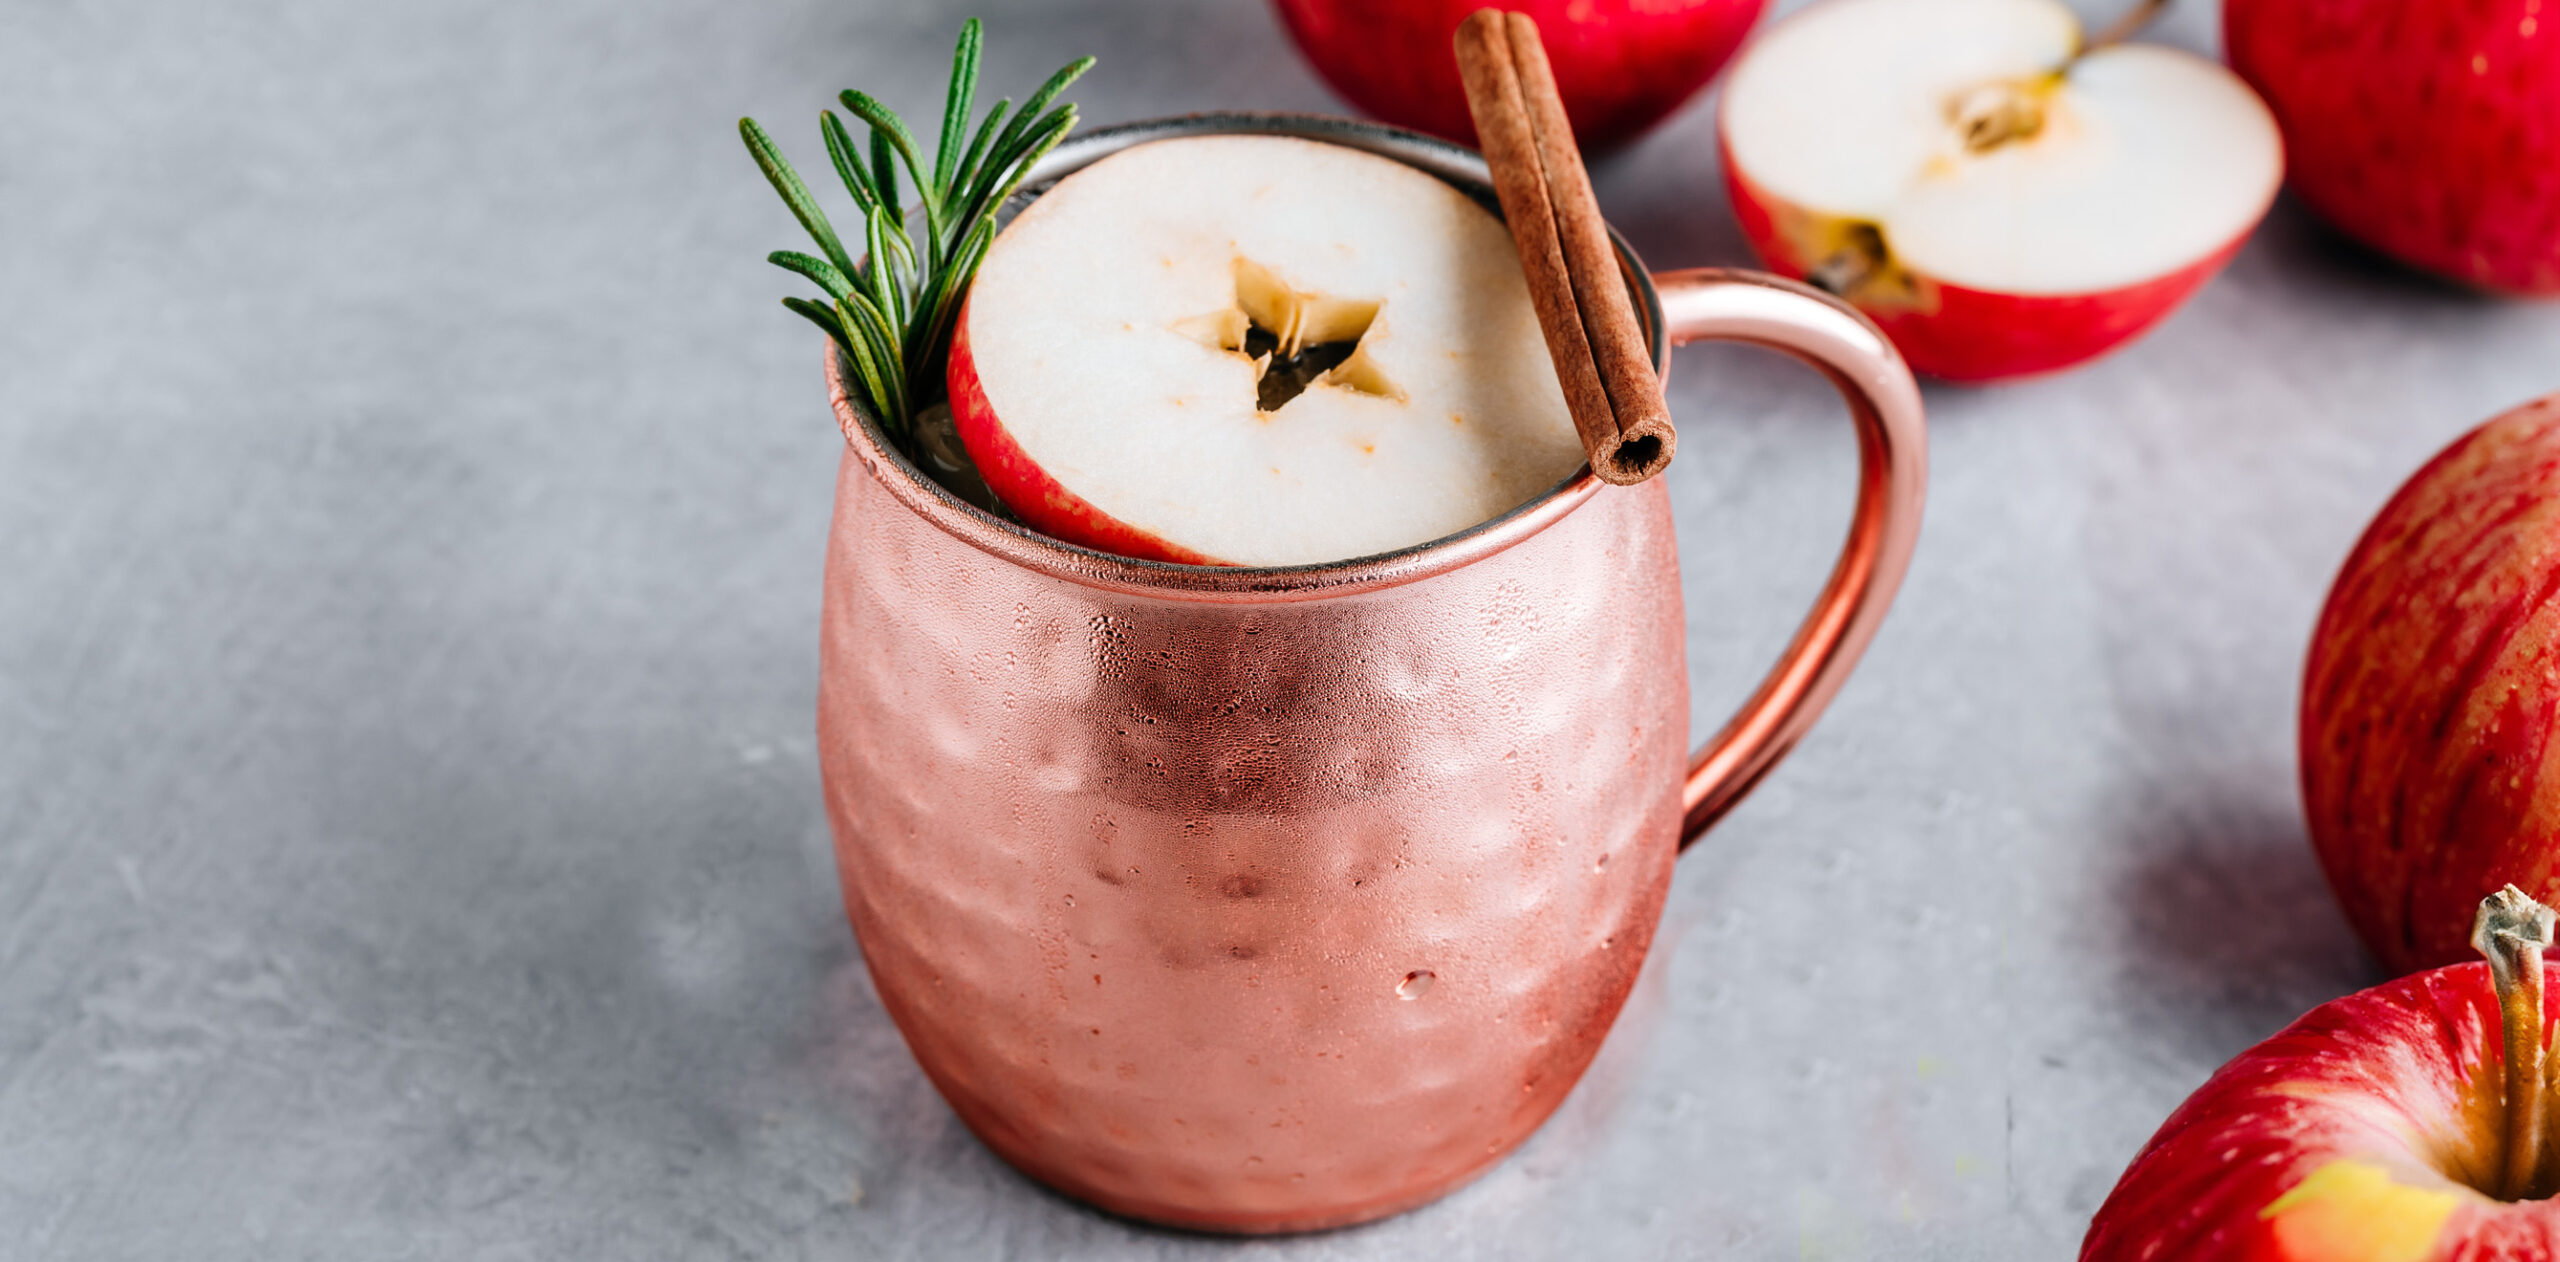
[1654,266,1928,850]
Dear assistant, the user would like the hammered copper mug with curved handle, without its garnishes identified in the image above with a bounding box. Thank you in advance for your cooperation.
[819,115,1925,1231]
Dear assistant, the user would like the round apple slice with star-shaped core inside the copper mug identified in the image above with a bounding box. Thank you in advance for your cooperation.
[950,136,1582,566]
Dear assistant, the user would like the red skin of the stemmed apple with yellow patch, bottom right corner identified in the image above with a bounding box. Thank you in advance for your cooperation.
[2081,960,2560,1262]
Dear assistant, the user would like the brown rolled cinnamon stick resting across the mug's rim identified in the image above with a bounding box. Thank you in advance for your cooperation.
[1457,8,1679,486]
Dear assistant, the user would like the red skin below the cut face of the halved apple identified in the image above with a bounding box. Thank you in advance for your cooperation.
[1723,146,2248,381]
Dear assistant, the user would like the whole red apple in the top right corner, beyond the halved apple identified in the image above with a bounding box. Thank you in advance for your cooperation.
[2222,0,2560,294]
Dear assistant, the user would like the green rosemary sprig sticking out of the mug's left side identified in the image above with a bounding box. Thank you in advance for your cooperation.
[737,18,1093,435]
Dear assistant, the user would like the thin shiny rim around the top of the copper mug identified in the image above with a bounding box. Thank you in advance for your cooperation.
[824,113,1667,604]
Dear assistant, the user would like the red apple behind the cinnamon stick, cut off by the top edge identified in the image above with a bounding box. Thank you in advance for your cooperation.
[1275,0,1766,151]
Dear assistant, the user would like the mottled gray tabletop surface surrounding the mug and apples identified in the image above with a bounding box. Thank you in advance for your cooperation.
[0,0,2560,1259]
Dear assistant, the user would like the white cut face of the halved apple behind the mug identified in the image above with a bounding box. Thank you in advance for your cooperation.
[1723,0,2284,294]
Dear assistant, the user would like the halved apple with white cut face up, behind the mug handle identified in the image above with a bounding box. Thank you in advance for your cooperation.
[1718,0,2284,381]
